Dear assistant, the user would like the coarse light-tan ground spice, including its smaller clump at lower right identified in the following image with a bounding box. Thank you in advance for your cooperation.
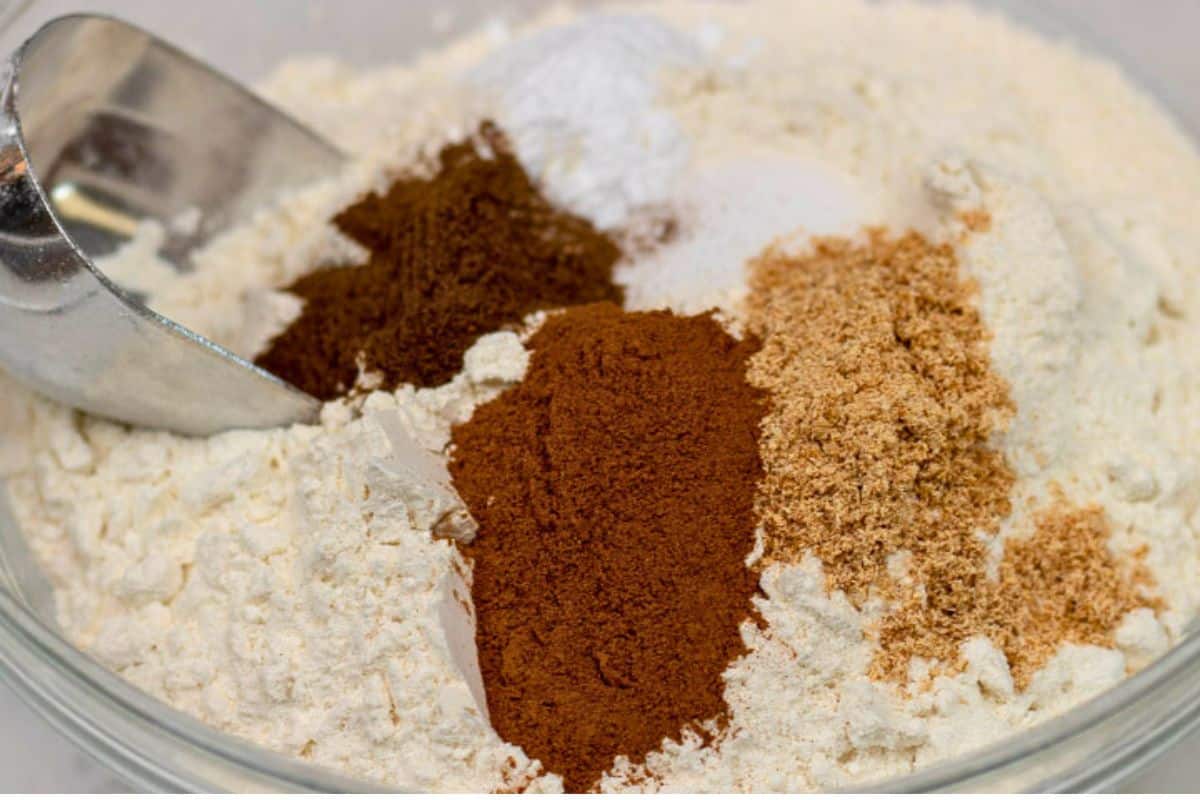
[748,230,1146,682]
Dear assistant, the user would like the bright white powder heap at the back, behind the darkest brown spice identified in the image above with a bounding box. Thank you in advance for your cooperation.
[470,16,702,230]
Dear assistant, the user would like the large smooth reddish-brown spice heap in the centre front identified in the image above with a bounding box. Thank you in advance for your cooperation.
[450,303,763,792]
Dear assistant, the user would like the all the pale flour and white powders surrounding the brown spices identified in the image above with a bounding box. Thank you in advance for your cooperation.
[0,0,1200,790]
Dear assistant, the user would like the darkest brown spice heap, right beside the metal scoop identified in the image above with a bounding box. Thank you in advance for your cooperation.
[257,122,622,399]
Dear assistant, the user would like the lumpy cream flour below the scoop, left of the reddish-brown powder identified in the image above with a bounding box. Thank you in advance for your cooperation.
[5,333,557,790]
